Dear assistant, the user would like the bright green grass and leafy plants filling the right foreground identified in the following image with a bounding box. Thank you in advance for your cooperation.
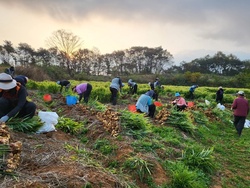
[4,83,250,188]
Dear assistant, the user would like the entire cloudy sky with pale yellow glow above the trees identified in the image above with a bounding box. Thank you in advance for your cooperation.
[0,0,250,63]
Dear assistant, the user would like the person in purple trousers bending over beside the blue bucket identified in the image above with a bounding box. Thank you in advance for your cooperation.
[72,83,92,103]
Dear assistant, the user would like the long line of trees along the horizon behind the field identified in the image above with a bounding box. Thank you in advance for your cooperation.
[0,30,250,86]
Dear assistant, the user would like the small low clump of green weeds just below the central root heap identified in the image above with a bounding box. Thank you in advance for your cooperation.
[94,139,117,155]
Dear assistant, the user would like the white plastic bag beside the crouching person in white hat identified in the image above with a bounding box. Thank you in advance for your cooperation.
[36,111,59,134]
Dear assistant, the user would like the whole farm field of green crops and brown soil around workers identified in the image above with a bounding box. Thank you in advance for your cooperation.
[0,80,250,188]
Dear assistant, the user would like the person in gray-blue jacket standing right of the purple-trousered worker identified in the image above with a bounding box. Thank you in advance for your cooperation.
[109,76,124,105]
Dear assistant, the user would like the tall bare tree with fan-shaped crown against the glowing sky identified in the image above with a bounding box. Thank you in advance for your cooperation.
[46,29,83,76]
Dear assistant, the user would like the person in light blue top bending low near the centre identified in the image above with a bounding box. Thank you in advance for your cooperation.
[135,90,156,118]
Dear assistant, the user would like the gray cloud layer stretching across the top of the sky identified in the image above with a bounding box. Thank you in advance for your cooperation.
[0,0,250,51]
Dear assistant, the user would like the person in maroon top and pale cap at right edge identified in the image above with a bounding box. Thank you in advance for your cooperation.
[231,91,249,136]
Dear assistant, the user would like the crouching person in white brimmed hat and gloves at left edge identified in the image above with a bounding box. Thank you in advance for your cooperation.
[0,73,36,123]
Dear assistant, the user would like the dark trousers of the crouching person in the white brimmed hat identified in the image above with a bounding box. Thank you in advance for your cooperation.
[0,97,36,118]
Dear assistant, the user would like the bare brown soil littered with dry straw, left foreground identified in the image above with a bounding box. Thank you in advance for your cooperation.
[0,91,174,188]
